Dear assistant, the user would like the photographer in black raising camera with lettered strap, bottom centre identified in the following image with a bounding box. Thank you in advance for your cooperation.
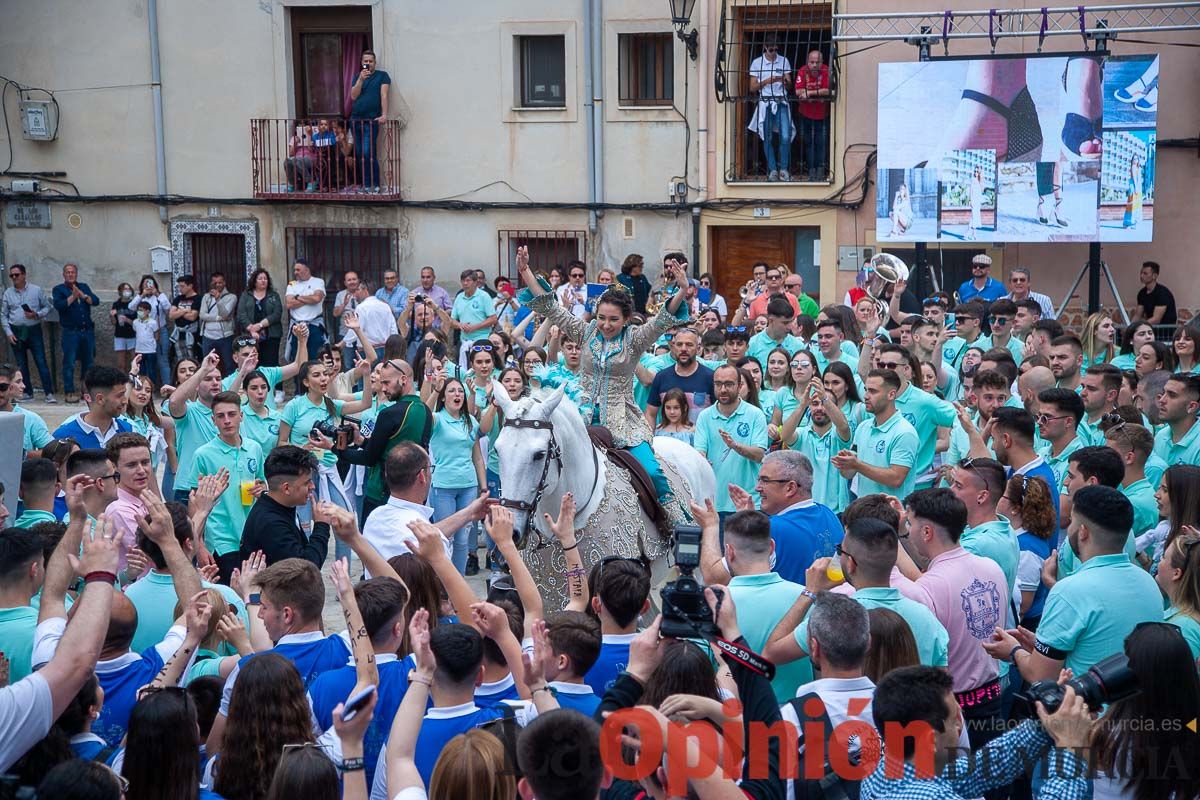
[596,587,785,800]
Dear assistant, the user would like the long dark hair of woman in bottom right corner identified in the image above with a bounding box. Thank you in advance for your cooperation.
[1088,622,1200,800]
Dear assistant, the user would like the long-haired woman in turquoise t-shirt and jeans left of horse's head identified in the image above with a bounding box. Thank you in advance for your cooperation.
[428,378,487,575]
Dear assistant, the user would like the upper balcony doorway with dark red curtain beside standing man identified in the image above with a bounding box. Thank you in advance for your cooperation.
[290,6,369,116]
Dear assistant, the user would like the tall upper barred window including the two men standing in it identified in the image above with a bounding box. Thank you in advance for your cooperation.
[714,0,838,182]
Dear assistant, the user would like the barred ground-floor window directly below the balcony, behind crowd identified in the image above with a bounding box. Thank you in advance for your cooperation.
[287,228,400,330]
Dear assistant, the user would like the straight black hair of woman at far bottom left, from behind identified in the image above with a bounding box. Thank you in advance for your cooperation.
[121,686,201,800]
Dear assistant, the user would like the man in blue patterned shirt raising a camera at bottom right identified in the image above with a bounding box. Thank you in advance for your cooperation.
[862,666,1099,800]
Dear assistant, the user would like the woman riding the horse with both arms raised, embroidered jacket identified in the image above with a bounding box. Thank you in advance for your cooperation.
[517,247,688,524]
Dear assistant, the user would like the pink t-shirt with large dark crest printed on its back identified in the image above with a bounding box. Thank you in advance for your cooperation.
[895,547,1008,692]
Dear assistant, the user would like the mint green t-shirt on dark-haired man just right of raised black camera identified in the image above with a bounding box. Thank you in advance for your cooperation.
[728,572,812,703]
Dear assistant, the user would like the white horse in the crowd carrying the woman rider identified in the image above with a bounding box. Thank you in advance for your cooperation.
[493,386,716,601]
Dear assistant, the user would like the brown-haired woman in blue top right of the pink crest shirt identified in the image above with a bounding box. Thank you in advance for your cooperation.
[996,475,1058,631]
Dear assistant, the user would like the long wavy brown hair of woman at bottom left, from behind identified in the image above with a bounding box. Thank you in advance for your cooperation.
[212,652,313,800]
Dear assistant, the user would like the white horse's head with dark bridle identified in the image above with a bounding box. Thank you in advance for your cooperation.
[493,386,573,536]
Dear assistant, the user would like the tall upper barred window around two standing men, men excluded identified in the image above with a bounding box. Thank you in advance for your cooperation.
[715,0,838,182]
